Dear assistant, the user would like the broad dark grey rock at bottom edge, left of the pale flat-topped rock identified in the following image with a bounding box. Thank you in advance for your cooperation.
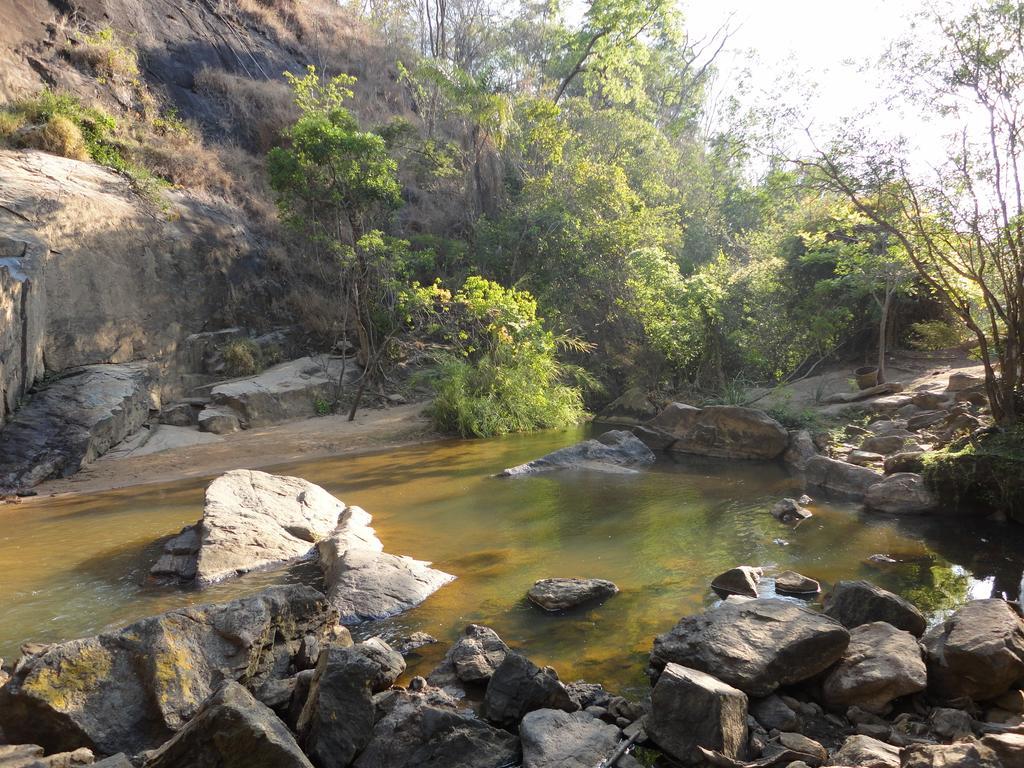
[356,691,519,768]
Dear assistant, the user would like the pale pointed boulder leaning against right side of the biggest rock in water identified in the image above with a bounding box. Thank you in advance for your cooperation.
[317,507,455,625]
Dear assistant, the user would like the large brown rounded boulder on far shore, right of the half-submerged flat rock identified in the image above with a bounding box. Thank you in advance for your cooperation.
[647,402,790,461]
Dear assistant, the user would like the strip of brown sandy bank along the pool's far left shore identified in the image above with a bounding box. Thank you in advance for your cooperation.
[26,402,439,503]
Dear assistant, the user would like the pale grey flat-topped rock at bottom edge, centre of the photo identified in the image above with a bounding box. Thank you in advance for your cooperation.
[519,710,620,768]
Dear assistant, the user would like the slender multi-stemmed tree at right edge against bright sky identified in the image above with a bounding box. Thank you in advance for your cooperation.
[807,2,1024,423]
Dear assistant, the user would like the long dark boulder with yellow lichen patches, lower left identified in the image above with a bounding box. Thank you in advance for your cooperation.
[0,586,335,755]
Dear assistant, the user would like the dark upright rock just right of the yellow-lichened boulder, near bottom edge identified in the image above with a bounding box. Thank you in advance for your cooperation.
[296,646,381,766]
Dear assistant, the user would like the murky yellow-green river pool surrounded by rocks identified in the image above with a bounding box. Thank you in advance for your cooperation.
[0,428,1024,692]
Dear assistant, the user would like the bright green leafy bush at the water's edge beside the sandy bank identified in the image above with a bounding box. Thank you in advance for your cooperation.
[403,275,584,437]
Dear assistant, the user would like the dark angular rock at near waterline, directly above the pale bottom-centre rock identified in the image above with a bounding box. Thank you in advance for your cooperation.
[480,651,579,727]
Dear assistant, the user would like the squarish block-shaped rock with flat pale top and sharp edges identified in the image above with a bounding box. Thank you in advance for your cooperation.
[647,664,746,765]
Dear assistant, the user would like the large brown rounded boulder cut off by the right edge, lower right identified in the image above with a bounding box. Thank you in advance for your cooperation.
[924,599,1024,701]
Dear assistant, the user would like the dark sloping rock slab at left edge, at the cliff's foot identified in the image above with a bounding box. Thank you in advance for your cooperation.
[0,364,154,487]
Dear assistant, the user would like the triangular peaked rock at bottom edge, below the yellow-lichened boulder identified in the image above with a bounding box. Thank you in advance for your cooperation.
[144,682,312,768]
